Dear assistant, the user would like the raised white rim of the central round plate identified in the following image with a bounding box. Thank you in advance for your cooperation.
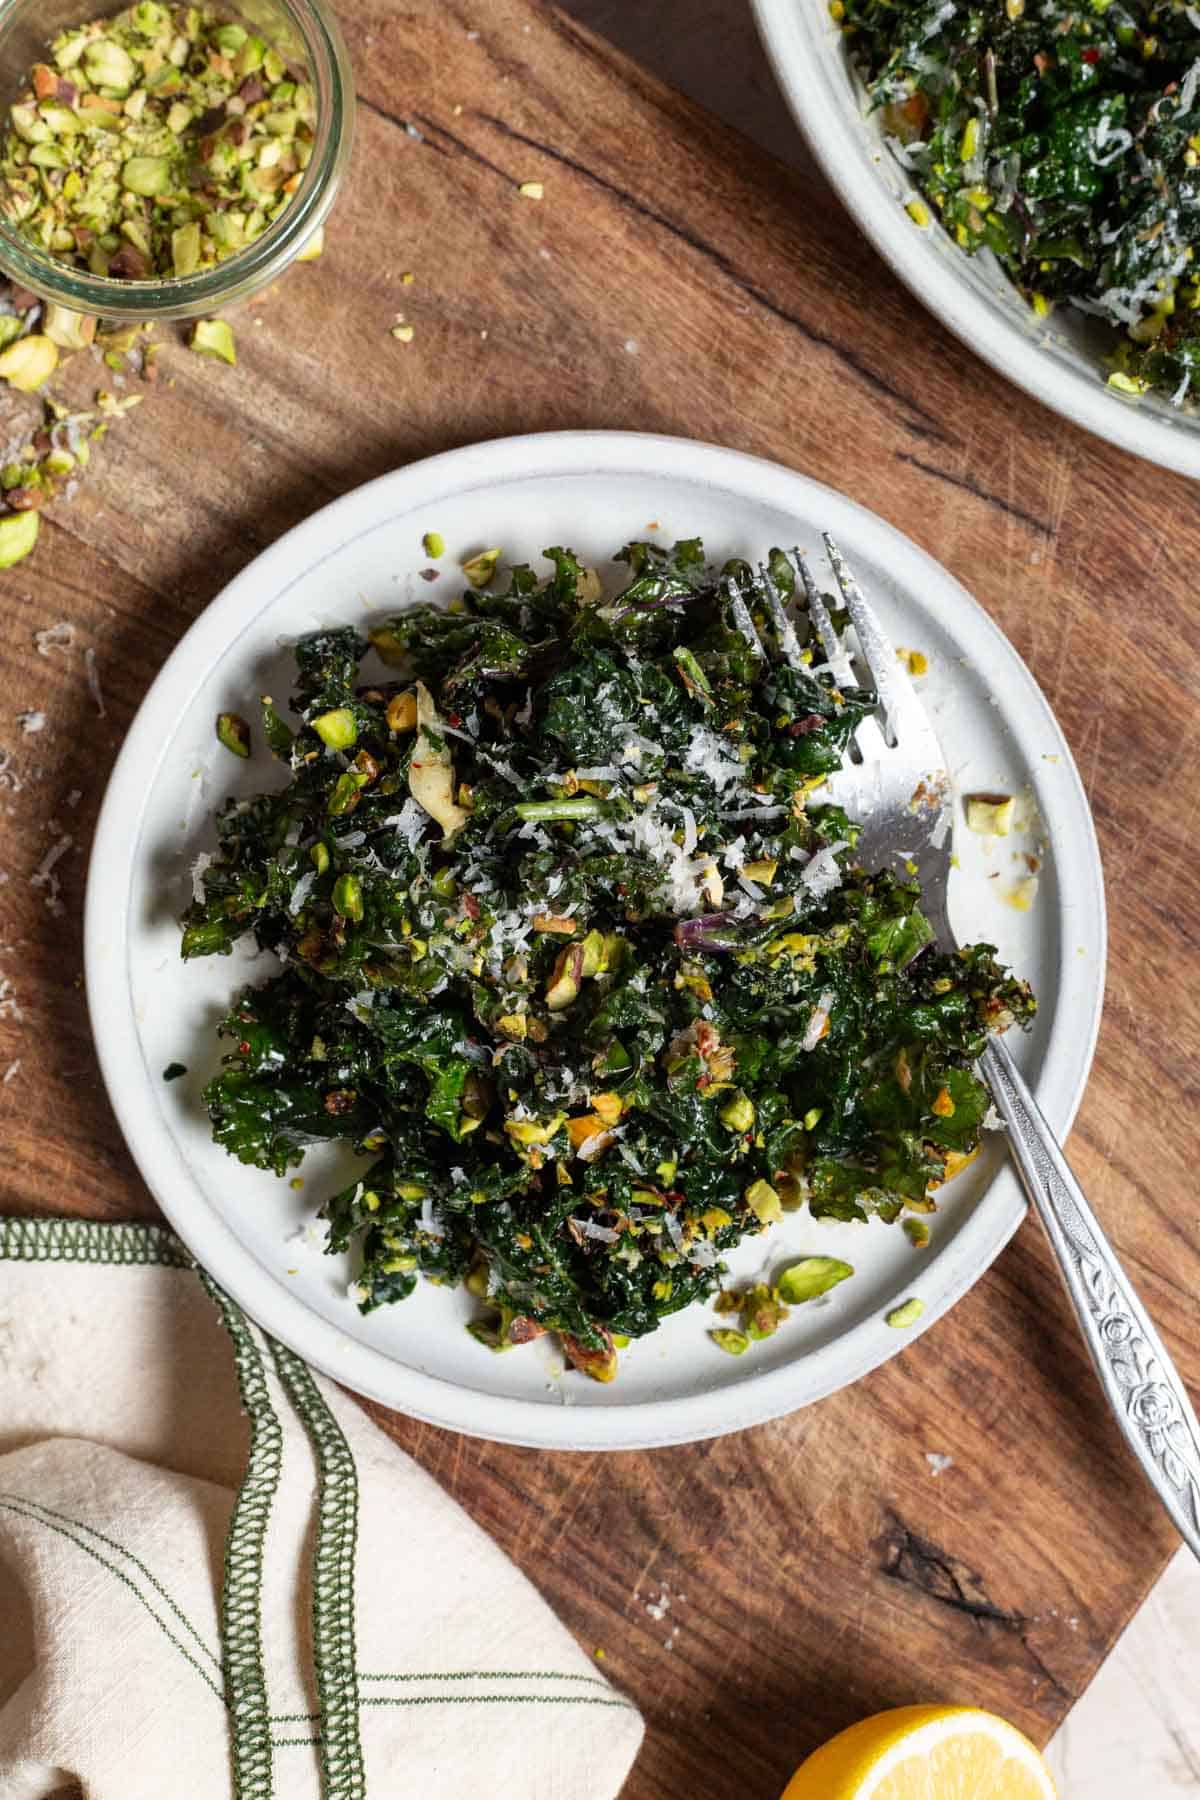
[85,430,1106,1451]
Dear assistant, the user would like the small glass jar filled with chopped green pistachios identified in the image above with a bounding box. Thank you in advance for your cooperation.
[0,0,354,319]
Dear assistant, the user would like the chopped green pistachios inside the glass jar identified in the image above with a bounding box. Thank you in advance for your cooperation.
[0,0,320,281]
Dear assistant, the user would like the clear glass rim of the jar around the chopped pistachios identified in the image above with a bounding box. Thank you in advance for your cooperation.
[0,0,354,320]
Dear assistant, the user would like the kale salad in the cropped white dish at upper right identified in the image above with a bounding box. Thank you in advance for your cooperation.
[831,0,1200,405]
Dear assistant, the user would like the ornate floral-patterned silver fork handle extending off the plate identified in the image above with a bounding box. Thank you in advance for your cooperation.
[981,1039,1200,1557]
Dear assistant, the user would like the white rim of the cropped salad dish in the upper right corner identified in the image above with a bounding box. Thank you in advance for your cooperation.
[750,0,1200,477]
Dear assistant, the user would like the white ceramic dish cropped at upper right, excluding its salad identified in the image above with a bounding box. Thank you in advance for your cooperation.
[754,0,1200,475]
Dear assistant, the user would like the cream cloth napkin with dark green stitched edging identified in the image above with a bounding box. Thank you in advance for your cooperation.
[0,1219,642,1800]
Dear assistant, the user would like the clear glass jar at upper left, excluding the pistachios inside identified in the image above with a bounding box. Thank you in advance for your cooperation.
[0,0,354,320]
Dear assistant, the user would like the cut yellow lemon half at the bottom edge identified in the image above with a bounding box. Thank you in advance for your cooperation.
[783,1706,1054,1800]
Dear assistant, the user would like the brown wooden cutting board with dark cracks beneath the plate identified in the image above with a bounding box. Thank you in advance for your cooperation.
[0,0,1200,1800]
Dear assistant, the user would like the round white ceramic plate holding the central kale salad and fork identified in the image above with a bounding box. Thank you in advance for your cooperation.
[86,432,1105,1449]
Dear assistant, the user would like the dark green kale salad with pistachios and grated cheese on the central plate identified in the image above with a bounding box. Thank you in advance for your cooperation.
[182,540,1034,1381]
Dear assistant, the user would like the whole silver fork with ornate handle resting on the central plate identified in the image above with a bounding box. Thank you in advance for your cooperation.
[734,533,1200,1557]
